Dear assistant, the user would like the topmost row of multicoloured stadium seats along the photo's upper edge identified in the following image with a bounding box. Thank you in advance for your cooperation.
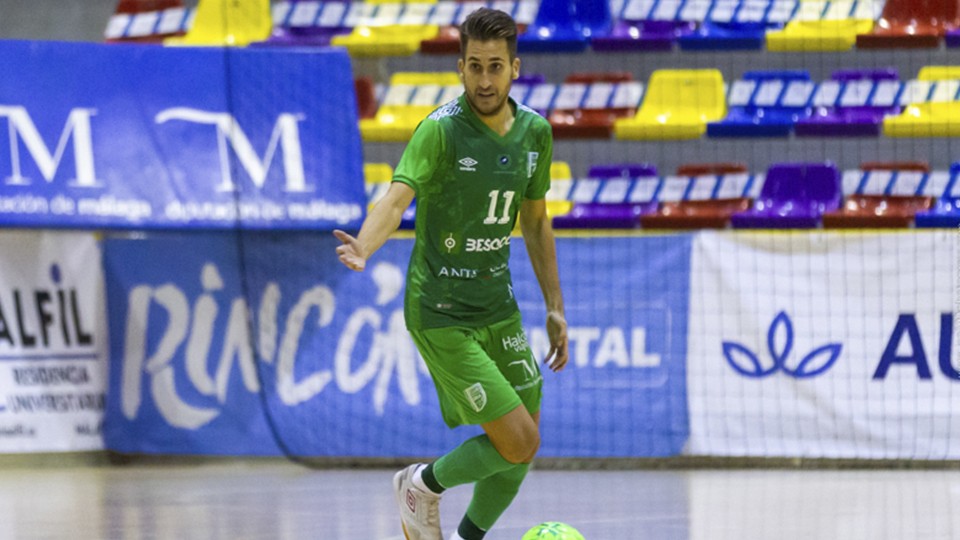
[105,0,960,52]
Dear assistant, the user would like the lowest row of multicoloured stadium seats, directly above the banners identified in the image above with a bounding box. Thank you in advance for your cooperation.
[365,162,960,229]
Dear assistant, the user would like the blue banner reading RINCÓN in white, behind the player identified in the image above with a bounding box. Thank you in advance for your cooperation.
[104,233,690,457]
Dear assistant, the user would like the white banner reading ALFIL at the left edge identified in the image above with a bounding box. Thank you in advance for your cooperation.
[0,231,108,453]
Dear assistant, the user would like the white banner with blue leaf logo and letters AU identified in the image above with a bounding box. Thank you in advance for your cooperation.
[686,230,960,459]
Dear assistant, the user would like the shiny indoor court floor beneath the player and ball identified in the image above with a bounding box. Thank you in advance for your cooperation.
[0,460,960,540]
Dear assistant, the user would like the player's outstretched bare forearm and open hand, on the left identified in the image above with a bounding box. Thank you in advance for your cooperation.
[333,182,415,272]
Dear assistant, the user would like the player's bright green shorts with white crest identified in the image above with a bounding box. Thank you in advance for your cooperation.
[410,313,543,428]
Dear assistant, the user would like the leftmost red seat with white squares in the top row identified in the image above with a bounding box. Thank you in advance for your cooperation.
[104,0,192,43]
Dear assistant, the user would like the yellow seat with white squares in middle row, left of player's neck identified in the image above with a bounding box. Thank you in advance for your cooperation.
[360,72,463,142]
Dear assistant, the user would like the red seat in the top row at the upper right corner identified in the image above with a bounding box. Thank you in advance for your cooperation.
[857,0,960,49]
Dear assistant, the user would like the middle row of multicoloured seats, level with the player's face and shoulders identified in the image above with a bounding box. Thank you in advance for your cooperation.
[357,66,960,142]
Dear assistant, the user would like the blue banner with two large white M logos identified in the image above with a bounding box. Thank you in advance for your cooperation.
[0,41,365,229]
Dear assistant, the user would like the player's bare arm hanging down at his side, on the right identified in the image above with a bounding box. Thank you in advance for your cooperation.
[519,199,569,371]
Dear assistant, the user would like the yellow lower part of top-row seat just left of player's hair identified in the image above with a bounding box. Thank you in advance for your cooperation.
[331,24,440,56]
